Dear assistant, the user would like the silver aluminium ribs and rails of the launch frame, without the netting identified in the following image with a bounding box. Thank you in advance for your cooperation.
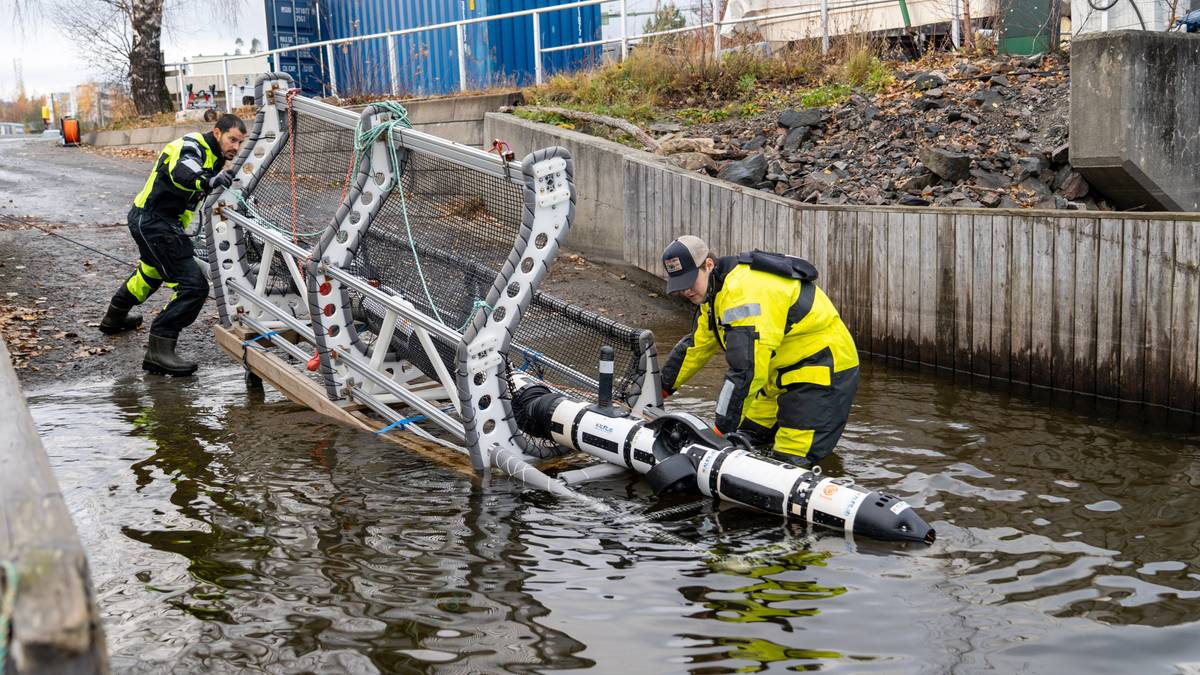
[204,73,660,482]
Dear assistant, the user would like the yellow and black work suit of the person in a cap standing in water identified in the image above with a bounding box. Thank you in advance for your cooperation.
[662,251,858,464]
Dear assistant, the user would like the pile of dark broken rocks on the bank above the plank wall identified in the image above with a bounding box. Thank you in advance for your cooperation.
[660,56,1110,210]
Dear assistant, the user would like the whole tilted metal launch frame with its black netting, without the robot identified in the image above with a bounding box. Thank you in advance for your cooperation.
[198,73,661,491]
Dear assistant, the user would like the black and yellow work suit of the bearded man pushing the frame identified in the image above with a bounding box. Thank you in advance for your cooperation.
[113,132,224,340]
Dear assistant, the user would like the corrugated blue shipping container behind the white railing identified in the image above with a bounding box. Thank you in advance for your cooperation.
[276,0,600,96]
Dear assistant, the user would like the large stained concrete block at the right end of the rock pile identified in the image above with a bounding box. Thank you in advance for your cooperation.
[1070,31,1200,211]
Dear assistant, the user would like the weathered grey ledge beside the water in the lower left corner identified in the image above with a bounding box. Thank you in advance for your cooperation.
[0,341,108,673]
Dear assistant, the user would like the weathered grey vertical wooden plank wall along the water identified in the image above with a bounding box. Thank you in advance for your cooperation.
[624,157,1200,413]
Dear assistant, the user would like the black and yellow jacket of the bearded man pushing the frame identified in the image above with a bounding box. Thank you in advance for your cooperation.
[133,132,224,226]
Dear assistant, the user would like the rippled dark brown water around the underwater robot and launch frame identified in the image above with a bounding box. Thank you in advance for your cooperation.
[30,353,1200,674]
